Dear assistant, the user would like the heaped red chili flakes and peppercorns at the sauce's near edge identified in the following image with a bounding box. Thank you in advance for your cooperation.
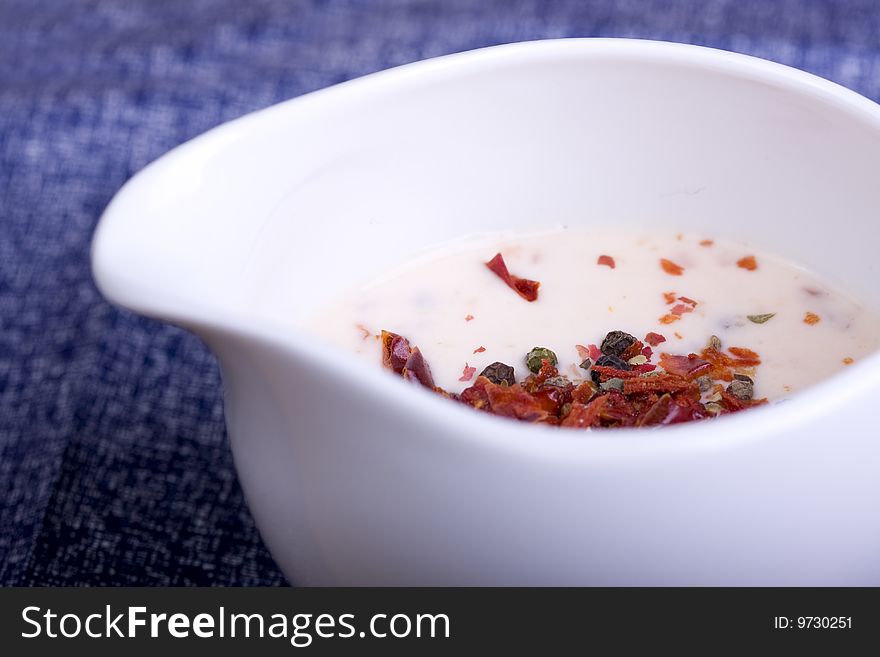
[380,331,767,429]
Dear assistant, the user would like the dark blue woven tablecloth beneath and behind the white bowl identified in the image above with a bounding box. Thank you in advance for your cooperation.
[0,0,880,585]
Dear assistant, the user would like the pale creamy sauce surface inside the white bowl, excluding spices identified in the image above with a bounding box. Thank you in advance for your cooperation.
[305,229,880,400]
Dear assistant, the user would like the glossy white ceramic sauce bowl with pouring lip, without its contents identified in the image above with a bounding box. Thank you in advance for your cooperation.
[93,40,880,585]
